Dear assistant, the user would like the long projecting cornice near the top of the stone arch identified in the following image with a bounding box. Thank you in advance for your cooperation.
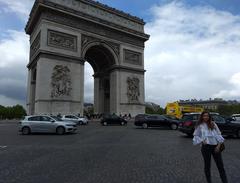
[25,0,149,41]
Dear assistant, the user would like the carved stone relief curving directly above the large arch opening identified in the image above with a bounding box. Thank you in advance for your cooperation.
[82,35,120,56]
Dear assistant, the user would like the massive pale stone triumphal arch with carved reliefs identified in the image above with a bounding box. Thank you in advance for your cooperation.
[25,0,149,115]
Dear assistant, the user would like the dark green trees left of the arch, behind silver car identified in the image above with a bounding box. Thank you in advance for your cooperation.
[0,105,27,119]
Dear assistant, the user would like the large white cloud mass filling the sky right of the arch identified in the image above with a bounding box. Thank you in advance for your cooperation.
[145,2,240,106]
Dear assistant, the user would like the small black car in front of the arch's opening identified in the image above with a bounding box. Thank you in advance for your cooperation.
[101,114,127,126]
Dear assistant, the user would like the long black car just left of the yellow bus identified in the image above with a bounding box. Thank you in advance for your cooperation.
[134,114,179,130]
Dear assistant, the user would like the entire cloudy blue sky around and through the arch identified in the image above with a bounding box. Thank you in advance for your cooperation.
[0,0,240,106]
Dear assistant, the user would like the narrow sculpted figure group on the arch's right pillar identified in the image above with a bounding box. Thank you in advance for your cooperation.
[127,77,140,103]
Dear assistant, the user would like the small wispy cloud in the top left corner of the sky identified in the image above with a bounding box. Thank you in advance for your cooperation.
[0,0,34,21]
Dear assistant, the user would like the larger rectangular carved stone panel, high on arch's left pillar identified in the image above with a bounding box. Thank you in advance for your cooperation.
[48,30,77,51]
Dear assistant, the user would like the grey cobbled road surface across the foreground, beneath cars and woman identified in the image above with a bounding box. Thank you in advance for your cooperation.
[0,123,240,183]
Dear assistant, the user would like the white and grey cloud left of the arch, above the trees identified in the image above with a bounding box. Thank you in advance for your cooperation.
[0,31,29,104]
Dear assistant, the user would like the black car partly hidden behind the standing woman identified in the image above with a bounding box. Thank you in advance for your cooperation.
[178,113,240,137]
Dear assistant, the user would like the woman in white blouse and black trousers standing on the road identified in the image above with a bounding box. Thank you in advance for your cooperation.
[193,112,228,183]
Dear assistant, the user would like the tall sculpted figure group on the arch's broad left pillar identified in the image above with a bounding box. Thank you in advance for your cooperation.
[51,65,72,98]
